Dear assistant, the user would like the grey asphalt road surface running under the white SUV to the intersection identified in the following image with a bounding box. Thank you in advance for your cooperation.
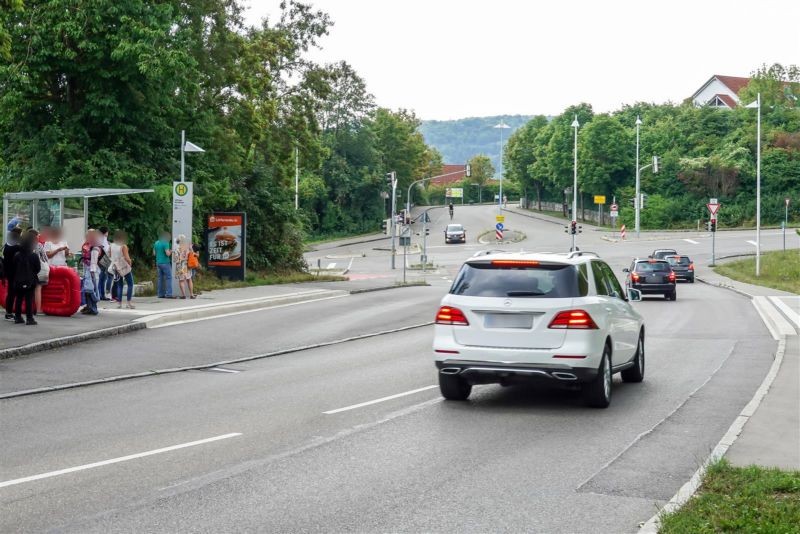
[0,207,775,533]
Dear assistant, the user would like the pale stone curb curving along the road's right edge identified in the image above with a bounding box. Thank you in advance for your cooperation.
[639,278,786,534]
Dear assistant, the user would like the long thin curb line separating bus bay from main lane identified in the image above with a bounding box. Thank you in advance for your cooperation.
[0,321,433,400]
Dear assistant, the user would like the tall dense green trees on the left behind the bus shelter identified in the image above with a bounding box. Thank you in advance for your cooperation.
[0,0,441,269]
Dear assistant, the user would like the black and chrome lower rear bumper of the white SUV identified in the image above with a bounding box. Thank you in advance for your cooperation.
[436,360,597,384]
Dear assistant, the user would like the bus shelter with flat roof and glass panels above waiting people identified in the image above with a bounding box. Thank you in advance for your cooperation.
[3,188,153,250]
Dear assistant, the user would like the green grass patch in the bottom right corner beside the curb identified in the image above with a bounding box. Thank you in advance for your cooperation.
[659,459,800,534]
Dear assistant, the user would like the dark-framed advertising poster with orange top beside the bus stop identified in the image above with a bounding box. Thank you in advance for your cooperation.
[206,212,247,280]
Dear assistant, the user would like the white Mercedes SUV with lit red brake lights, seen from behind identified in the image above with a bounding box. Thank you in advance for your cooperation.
[433,252,645,408]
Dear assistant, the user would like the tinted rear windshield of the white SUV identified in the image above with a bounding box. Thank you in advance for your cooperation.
[450,262,588,298]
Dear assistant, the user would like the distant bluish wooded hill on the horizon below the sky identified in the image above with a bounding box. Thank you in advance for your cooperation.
[419,115,531,170]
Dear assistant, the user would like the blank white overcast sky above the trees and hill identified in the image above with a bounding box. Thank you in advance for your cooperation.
[245,0,800,119]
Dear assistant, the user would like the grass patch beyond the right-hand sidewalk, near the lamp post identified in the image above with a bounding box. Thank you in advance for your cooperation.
[714,249,800,293]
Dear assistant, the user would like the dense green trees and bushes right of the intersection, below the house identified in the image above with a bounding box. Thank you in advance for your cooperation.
[503,65,800,228]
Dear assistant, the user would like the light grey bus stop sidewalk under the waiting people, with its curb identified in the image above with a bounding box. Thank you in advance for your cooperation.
[0,279,394,360]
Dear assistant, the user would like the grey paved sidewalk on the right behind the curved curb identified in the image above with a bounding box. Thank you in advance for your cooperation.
[698,269,800,470]
